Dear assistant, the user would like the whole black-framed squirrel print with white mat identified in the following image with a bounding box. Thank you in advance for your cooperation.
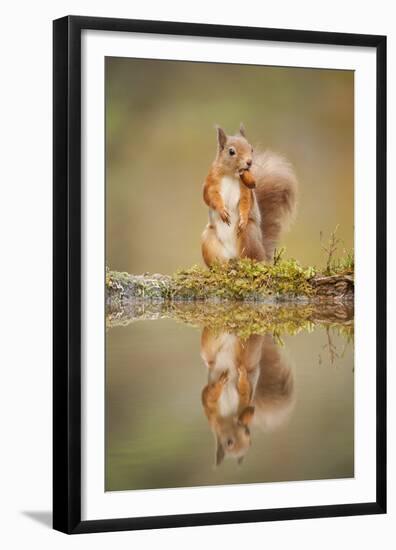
[53,16,386,533]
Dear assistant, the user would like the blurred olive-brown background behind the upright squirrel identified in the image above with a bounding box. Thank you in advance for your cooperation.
[106,58,354,273]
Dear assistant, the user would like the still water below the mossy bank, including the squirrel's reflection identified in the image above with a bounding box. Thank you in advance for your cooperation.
[105,308,354,491]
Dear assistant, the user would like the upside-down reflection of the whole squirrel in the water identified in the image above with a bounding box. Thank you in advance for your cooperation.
[201,328,294,465]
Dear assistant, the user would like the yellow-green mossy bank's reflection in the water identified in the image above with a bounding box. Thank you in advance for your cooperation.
[106,300,353,339]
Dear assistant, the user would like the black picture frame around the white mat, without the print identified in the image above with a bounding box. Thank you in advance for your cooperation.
[53,16,386,534]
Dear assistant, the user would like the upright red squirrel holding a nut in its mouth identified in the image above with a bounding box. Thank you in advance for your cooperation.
[202,125,297,266]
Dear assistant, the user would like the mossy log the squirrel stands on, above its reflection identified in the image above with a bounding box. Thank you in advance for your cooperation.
[106,260,354,307]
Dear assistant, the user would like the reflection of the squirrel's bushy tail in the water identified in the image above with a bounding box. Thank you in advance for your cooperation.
[254,335,295,431]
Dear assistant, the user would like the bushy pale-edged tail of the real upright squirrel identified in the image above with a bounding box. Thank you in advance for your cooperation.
[252,151,298,261]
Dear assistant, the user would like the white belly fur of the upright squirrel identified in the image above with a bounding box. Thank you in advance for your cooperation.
[210,176,241,258]
